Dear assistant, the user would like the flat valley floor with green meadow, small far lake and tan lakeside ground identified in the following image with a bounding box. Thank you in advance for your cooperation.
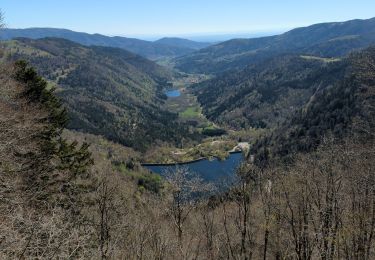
[143,74,248,164]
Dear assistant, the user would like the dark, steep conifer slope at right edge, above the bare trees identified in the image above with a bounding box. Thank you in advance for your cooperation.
[252,47,375,160]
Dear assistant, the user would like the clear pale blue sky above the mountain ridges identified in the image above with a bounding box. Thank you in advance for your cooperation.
[0,0,375,38]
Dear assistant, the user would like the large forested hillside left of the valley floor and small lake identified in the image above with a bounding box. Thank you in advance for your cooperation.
[3,38,200,150]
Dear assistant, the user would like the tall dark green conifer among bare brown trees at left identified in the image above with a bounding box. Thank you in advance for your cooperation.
[14,61,93,207]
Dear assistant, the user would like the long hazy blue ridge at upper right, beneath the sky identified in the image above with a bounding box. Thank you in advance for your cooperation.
[175,18,375,74]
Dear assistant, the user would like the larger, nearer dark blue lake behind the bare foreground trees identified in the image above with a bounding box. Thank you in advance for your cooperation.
[144,153,244,183]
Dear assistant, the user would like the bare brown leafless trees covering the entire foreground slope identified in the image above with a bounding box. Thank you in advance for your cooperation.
[0,52,375,259]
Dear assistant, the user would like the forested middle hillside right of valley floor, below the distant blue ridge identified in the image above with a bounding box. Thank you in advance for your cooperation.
[194,55,344,129]
